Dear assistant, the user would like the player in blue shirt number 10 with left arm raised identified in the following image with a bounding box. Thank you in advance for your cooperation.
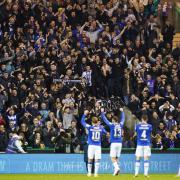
[81,110,107,177]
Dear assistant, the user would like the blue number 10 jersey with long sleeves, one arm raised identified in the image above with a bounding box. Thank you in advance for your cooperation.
[81,115,106,146]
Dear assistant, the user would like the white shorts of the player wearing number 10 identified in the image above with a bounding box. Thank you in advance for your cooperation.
[88,145,101,159]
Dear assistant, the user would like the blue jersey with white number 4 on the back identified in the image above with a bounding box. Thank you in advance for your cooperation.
[135,123,152,146]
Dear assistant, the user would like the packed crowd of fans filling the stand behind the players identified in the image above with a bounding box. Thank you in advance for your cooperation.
[0,0,180,152]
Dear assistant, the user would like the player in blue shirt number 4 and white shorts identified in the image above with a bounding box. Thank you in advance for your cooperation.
[134,115,152,177]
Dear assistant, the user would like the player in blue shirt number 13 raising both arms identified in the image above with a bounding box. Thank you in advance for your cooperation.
[101,108,125,175]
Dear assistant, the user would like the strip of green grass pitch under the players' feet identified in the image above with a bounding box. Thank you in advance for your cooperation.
[0,174,180,180]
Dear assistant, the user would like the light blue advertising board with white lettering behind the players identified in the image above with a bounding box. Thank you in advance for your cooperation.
[0,154,180,174]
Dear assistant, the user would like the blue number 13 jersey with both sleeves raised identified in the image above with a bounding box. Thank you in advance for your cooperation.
[101,112,125,143]
